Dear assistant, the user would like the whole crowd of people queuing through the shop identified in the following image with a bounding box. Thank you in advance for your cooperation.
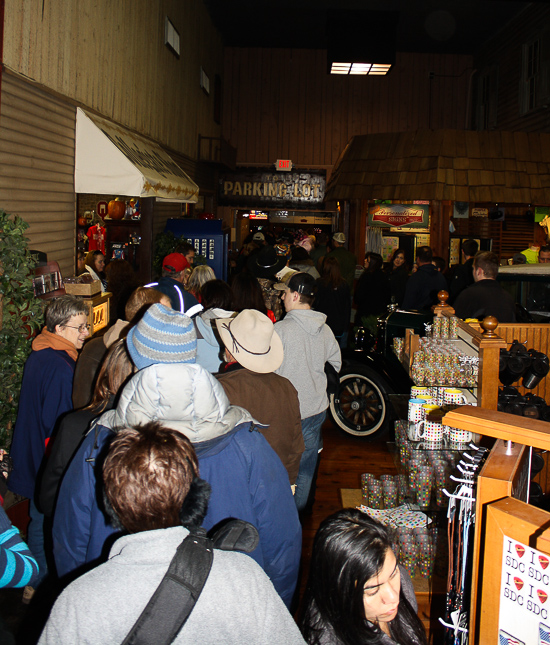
[5,225,550,644]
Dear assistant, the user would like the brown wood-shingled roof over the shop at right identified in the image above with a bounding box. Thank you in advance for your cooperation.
[327,130,550,204]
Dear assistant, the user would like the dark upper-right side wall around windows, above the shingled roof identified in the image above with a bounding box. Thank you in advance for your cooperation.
[474,2,550,132]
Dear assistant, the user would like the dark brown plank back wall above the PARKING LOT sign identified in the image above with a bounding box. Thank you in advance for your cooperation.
[223,48,472,169]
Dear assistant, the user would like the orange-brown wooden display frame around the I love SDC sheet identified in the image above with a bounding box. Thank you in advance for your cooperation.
[443,406,550,643]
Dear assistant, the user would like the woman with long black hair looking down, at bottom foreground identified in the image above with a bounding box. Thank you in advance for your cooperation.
[300,508,428,645]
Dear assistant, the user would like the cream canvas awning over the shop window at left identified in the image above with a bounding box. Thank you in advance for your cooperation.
[74,108,199,203]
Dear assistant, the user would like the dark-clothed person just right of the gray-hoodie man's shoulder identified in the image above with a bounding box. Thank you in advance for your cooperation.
[313,256,351,347]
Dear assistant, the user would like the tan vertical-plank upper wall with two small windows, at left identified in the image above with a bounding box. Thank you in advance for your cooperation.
[3,0,223,159]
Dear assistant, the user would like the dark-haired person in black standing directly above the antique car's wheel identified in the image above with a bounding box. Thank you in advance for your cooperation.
[354,253,391,331]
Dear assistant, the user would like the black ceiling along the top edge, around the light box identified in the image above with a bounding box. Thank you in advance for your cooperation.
[204,0,550,54]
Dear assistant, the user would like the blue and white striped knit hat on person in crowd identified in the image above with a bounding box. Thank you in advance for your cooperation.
[126,304,197,370]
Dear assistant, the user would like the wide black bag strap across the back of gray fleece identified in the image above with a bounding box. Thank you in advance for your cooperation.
[123,529,214,645]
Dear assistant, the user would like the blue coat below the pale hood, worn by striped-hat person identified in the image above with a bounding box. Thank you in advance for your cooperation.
[53,422,302,606]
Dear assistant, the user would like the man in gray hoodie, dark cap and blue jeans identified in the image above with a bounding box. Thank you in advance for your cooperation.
[275,273,342,512]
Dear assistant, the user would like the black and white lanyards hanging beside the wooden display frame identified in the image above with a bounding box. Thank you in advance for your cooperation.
[439,444,489,645]
